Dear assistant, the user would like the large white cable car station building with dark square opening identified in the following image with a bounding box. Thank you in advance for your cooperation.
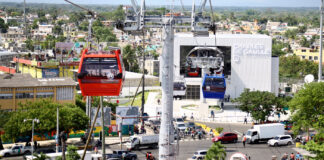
[171,33,279,99]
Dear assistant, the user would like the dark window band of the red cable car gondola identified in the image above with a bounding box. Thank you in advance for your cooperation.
[81,58,120,79]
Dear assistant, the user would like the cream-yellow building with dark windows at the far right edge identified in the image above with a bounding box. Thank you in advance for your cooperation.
[293,47,324,63]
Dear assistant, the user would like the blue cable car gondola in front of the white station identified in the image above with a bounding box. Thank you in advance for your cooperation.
[202,74,226,99]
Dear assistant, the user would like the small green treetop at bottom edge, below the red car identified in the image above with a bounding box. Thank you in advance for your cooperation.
[206,142,226,160]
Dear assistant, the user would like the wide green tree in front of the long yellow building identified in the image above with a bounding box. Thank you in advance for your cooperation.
[4,100,88,139]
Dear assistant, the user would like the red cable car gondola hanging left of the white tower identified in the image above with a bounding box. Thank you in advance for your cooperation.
[78,48,125,96]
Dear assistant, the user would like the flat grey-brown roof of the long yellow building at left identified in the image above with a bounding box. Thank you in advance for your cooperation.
[0,74,76,88]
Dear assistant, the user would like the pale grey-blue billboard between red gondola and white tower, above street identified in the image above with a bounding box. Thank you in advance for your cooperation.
[116,107,139,125]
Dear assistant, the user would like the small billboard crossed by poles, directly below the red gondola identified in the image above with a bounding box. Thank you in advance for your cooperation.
[91,107,111,127]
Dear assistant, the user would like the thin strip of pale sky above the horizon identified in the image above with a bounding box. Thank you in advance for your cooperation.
[0,0,321,7]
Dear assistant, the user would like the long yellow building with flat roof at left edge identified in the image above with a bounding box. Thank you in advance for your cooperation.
[0,74,76,110]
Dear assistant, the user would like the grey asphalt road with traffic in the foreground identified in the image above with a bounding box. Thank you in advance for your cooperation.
[110,123,296,160]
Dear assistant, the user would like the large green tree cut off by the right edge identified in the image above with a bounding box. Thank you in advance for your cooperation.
[289,82,324,160]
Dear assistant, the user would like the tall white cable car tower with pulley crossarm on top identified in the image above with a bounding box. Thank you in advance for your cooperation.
[116,0,211,160]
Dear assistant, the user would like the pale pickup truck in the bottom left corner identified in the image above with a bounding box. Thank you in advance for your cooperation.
[0,144,32,157]
